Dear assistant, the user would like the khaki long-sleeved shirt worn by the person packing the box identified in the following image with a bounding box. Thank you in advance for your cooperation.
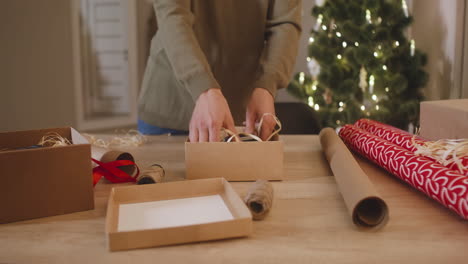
[138,0,301,130]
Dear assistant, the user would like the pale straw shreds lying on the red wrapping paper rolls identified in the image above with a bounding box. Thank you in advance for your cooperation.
[412,137,468,174]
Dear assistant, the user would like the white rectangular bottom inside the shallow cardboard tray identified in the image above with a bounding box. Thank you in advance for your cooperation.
[117,195,233,231]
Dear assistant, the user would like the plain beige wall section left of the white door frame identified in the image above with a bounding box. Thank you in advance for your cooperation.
[0,0,75,131]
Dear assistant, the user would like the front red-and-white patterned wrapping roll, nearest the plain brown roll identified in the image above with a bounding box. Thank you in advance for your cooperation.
[339,125,468,219]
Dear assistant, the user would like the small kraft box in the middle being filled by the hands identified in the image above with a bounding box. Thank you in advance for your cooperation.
[185,139,283,181]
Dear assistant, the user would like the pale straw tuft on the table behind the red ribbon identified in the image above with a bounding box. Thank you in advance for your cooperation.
[84,129,147,148]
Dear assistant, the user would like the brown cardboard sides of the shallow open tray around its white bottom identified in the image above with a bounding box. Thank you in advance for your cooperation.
[106,178,252,251]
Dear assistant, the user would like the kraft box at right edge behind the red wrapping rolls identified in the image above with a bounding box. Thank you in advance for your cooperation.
[420,99,468,140]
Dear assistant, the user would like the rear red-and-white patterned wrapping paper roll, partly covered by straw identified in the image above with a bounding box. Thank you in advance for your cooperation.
[354,119,468,176]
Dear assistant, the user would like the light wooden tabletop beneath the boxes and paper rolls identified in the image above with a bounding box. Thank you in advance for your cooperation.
[0,136,468,264]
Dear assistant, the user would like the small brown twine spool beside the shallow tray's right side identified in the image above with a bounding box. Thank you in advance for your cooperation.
[244,180,273,220]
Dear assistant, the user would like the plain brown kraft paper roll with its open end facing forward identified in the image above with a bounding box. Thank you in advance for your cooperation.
[320,128,389,229]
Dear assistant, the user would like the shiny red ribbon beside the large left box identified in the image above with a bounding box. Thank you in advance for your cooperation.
[91,159,140,186]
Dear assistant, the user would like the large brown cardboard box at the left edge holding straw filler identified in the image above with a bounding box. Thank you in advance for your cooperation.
[0,127,94,223]
